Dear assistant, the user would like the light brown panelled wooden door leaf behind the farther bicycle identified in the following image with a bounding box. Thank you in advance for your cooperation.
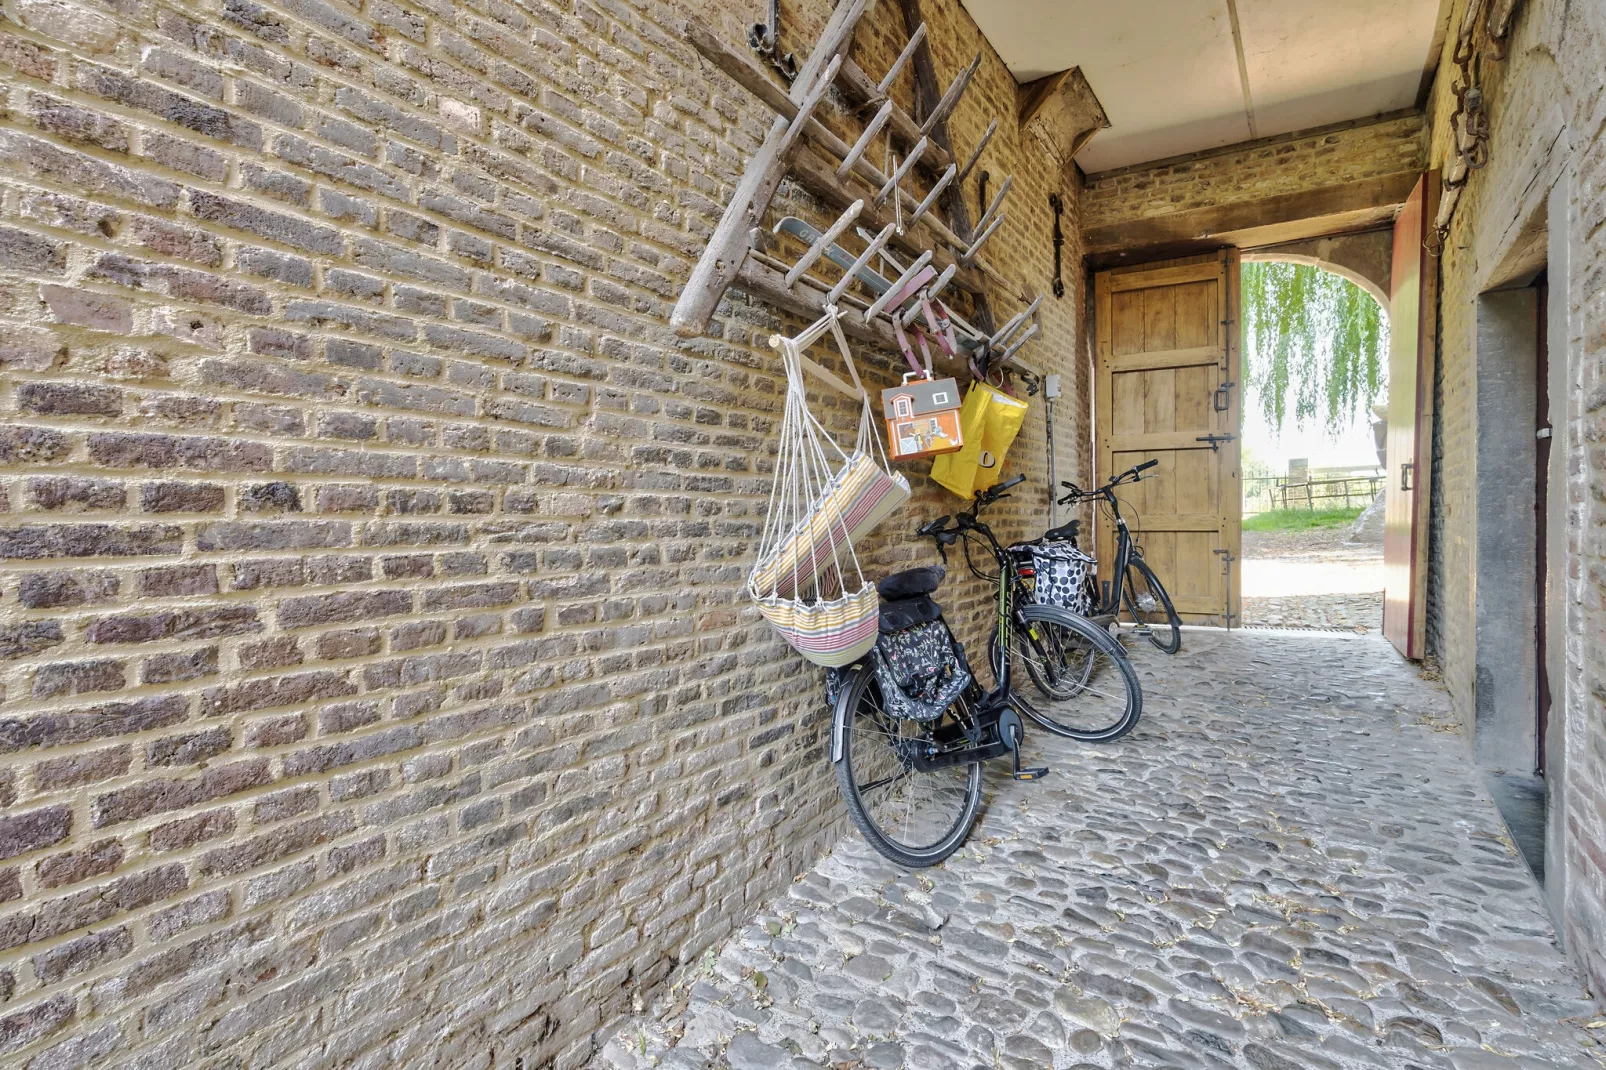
[1094,249,1243,627]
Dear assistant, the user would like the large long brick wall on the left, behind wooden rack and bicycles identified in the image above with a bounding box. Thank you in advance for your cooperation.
[0,0,1087,1068]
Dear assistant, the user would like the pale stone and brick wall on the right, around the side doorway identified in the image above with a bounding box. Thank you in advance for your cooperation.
[1429,0,1606,994]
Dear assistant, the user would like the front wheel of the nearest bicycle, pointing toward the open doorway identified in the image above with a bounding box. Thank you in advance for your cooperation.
[1010,606,1143,742]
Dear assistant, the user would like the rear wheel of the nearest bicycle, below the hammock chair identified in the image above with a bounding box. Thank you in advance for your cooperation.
[837,667,981,868]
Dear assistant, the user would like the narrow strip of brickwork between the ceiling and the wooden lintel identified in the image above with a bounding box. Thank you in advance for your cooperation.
[1082,114,1426,227]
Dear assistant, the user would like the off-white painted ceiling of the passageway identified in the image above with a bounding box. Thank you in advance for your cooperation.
[964,0,1441,174]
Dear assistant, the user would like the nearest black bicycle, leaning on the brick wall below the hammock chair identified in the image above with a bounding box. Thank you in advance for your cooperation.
[830,477,1143,868]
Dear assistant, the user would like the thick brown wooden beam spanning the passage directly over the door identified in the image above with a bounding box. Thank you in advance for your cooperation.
[1082,170,1421,263]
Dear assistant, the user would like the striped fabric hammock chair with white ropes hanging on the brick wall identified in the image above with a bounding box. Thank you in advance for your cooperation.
[747,305,909,667]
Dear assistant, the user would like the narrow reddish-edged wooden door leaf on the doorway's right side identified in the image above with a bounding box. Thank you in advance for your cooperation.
[1383,172,1439,659]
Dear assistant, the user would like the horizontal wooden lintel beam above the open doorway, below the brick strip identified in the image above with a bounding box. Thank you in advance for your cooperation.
[1082,170,1421,257]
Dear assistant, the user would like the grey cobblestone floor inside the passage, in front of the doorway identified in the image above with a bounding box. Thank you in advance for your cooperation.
[597,630,1606,1070]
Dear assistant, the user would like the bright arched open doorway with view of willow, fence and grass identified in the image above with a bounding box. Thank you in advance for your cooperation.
[1241,253,1389,633]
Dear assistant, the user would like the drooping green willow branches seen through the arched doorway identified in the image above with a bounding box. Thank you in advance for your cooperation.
[1243,260,1389,434]
